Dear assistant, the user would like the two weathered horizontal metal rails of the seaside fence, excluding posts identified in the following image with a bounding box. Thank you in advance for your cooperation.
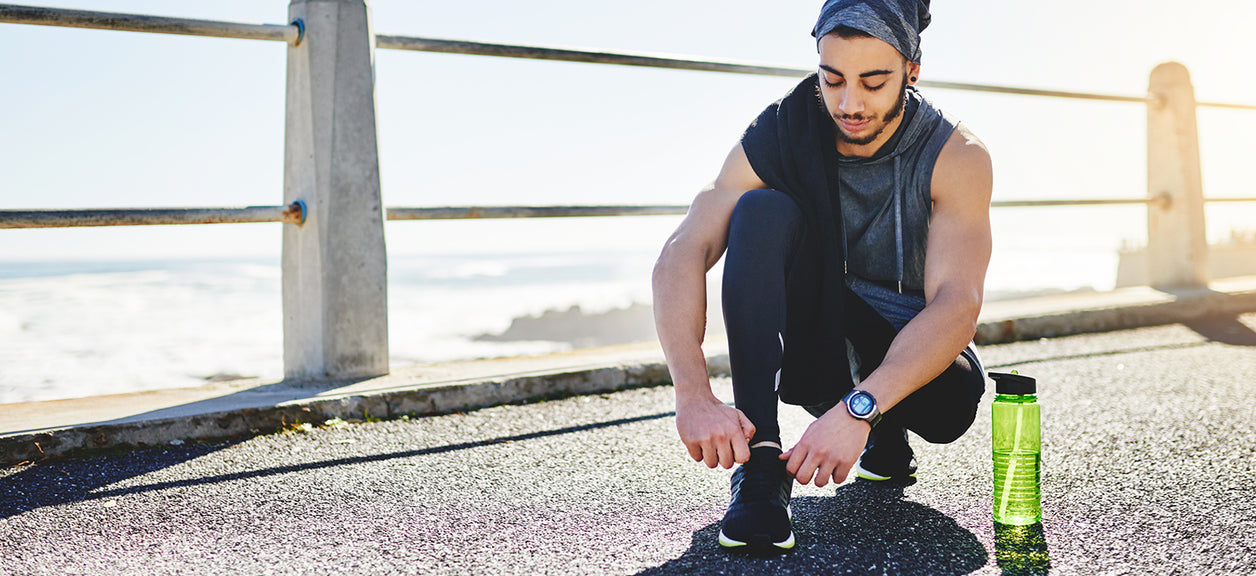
[0,4,1256,230]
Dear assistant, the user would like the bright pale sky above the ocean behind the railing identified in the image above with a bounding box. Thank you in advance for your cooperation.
[0,0,1256,261]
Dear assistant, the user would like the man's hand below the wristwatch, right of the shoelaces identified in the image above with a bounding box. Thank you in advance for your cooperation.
[781,404,872,488]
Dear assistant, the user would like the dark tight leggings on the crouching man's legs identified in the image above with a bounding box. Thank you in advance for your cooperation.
[723,189,986,443]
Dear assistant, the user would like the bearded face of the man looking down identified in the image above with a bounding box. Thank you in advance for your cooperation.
[819,34,919,156]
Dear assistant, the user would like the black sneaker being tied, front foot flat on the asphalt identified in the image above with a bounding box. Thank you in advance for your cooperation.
[720,445,794,553]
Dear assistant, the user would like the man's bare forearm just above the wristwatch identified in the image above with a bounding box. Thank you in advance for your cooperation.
[859,294,981,413]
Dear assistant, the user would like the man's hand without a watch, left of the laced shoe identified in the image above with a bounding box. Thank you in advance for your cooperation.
[676,397,755,468]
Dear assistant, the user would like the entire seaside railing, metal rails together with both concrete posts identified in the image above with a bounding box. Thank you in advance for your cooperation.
[0,0,1256,378]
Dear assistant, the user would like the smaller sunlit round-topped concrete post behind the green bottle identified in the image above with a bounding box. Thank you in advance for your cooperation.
[1147,61,1208,287]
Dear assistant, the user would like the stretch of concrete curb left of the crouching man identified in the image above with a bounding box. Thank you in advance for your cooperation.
[0,355,728,467]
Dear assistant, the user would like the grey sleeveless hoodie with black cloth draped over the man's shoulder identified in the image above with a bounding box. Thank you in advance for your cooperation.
[741,74,957,405]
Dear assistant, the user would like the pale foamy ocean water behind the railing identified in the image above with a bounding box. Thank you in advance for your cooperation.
[0,206,1256,403]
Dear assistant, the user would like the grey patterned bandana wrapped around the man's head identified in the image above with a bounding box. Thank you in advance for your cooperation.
[811,0,929,64]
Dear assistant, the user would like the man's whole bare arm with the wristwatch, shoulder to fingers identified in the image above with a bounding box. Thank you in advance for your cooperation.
[782,125,993,486]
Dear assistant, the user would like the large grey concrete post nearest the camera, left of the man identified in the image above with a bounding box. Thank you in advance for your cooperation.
[283,0,388,379]
